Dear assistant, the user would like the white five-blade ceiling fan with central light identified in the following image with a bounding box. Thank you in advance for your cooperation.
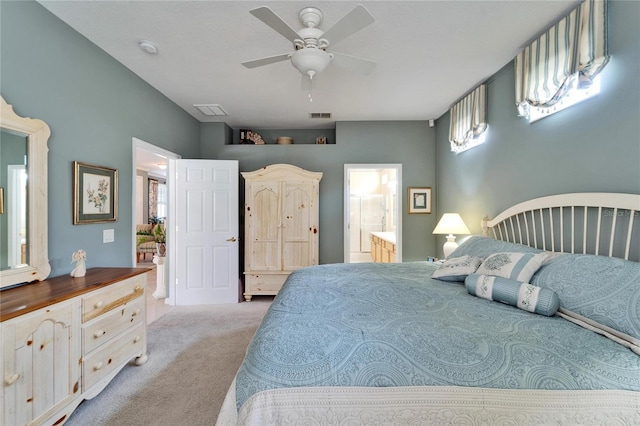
[242,5,376,85]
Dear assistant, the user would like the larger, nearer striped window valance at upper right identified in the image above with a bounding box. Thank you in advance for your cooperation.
[515,0,609,117]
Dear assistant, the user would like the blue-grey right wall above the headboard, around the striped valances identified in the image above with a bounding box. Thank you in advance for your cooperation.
[436,1,640,254]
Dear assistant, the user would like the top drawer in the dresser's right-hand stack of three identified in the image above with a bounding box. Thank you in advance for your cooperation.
[82,274,146,322]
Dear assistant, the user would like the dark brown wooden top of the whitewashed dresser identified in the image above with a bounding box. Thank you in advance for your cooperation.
[0,268,151,322]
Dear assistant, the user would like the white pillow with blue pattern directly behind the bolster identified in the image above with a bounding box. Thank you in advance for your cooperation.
[476,252,547,283]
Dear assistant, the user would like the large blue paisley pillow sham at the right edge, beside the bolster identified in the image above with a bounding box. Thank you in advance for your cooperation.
[531,254,640,353]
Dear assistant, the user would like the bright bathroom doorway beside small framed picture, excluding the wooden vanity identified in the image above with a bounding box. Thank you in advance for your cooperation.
[344,164,402,263]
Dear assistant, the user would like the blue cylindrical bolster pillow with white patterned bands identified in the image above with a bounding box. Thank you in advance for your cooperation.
[465,274,560,317]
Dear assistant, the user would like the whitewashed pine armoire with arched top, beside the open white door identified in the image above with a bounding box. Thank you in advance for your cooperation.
[242,164,322,301]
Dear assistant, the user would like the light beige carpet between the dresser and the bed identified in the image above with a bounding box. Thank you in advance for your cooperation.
[66,297,273,426]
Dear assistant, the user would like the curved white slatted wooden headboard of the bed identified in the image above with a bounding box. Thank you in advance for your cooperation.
[482,192,640,262]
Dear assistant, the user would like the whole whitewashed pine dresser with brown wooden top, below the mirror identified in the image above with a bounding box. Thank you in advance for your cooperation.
[0,268,148,426]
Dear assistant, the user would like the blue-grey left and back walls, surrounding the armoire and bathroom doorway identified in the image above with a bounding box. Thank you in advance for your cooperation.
[0,1,436,276]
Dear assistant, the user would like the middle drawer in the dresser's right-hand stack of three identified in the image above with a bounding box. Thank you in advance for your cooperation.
[82,297,145,353]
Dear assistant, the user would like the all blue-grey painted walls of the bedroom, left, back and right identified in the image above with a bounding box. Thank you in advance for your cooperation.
[11,1,640,276]
